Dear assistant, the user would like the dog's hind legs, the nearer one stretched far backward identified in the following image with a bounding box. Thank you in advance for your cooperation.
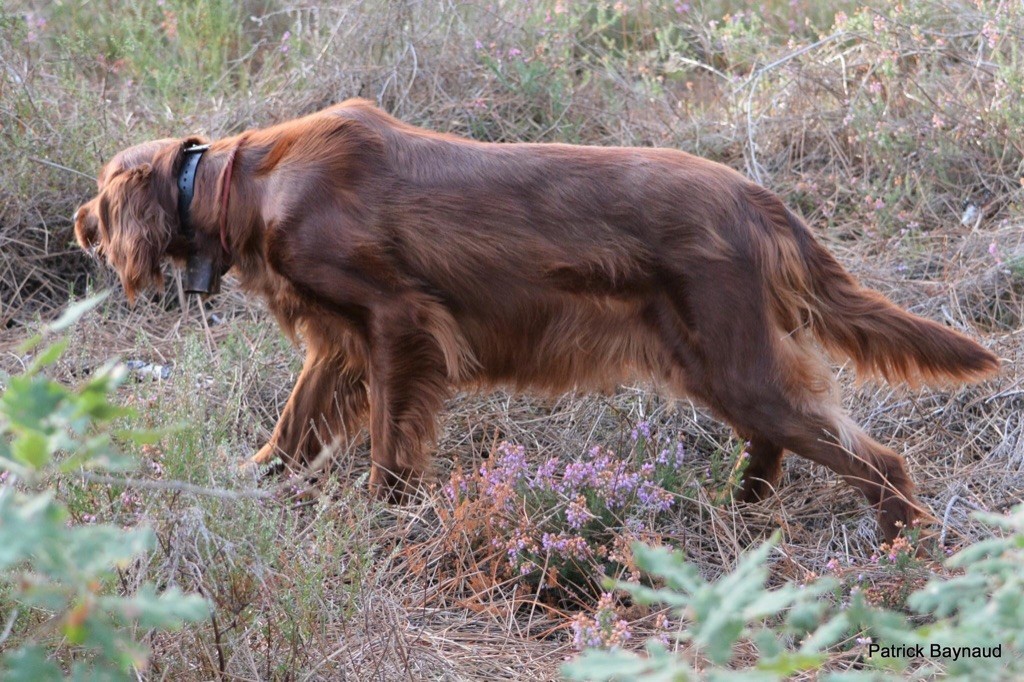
[649,264,921,540]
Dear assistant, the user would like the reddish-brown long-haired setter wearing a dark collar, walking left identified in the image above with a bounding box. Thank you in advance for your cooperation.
[75,100,998,539]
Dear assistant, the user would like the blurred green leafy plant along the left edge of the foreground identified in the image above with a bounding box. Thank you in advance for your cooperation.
[0,296,208,681]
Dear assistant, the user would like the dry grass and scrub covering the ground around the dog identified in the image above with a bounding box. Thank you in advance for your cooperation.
[0,0,1024,680]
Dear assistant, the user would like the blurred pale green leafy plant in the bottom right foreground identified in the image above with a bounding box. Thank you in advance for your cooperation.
[563,505,1024,680]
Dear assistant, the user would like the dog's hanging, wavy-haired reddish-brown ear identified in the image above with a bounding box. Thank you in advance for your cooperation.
[97,164,177,302]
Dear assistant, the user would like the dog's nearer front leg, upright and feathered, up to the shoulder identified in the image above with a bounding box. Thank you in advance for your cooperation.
[267,222,451,493]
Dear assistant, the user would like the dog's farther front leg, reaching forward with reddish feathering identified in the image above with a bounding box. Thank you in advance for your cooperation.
[250,349,369,469]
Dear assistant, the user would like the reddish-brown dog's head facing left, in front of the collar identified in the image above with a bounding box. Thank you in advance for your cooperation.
[74,137,225,301]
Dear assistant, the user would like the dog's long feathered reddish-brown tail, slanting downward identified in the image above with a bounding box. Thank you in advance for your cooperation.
[755,187,999,384]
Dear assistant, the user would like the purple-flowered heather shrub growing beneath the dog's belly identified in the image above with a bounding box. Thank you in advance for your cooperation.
[445,423,685,593]
